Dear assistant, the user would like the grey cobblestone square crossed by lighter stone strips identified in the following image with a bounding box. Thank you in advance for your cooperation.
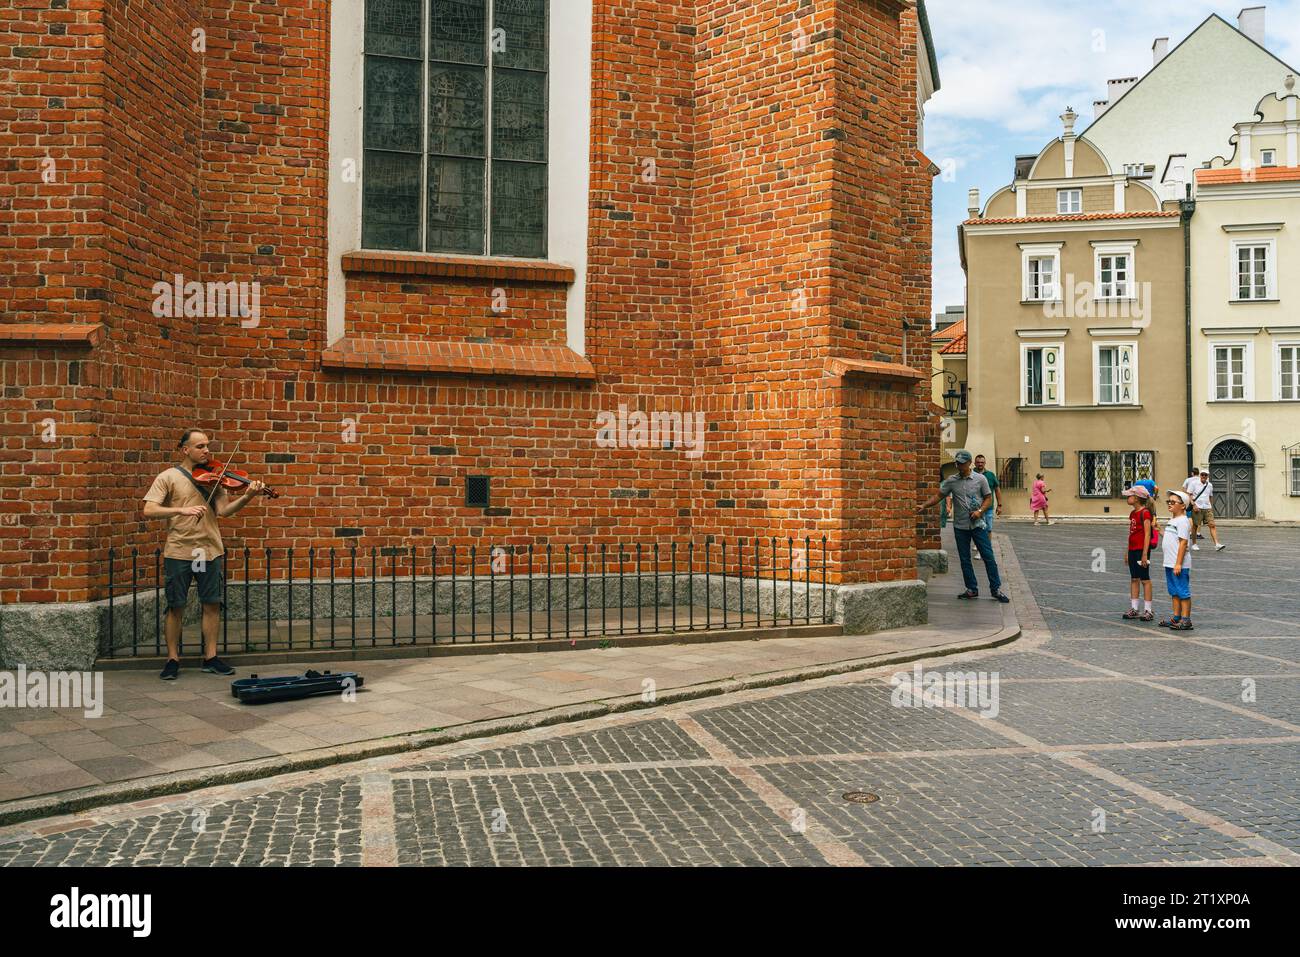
[0,523,1300,866]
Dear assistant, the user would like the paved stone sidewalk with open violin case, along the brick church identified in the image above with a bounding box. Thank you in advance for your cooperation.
[0,532,1019,823]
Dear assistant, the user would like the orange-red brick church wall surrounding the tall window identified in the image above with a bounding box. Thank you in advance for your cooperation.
[0,0,928,601]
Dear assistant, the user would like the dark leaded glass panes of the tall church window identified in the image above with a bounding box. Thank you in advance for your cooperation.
[361,0,547,257]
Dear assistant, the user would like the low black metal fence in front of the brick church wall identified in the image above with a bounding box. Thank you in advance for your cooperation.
[100,537,831,658]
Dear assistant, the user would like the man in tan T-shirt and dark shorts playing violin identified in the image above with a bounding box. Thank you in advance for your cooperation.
[143,429,263,681]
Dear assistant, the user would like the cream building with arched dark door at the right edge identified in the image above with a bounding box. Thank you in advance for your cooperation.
[1191,85,1300,521]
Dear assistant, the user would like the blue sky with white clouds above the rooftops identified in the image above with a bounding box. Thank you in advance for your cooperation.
[926,0,1300,319]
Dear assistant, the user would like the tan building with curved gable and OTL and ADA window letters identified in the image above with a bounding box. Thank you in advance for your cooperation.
[959,111,1188,515]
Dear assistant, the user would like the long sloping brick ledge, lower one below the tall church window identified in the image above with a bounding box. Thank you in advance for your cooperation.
[321,338,595,381]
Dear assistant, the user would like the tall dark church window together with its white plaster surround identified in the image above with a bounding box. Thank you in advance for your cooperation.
[326,0,593,345]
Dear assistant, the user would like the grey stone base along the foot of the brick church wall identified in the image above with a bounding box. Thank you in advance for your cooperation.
[0,573,927,671]
